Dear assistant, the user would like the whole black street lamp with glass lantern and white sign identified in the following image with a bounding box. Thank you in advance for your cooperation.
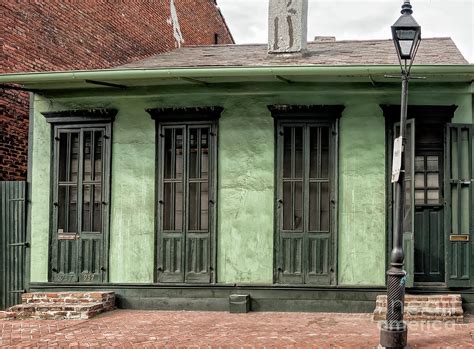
[380,0,421,348]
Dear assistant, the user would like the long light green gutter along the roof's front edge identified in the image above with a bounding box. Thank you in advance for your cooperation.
[0,64,474,84]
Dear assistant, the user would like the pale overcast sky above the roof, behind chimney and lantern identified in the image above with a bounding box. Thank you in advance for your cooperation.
[217,0,474,63]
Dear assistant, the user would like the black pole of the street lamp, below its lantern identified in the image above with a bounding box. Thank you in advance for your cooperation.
[380,70,409,348]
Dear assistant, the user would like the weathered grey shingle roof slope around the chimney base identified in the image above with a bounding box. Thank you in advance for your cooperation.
[119,38,468,69]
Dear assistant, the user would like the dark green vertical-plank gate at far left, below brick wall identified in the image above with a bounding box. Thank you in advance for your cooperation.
[0,182,29,309]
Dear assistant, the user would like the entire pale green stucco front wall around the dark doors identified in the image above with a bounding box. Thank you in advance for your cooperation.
[30,83,472,286]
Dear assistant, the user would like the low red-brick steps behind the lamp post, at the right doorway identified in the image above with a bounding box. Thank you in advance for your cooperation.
[373,294,464,322]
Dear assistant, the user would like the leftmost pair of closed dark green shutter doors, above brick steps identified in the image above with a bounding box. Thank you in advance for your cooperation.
[51,126,111,282]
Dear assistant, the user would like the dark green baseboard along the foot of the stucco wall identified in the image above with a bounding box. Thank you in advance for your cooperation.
[26,283,474,313]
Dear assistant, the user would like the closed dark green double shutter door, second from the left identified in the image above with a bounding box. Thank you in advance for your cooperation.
[158,123,216,283]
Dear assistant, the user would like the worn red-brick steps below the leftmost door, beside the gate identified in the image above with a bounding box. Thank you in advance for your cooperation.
[0,291,115,320]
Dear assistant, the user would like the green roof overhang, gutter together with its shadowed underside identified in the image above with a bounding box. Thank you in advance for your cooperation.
[0,64,474,91]
